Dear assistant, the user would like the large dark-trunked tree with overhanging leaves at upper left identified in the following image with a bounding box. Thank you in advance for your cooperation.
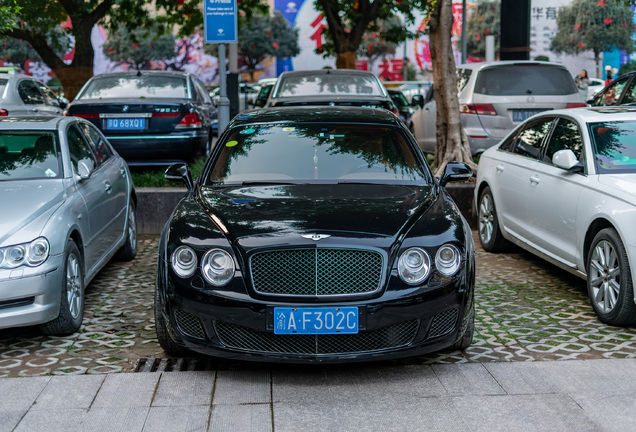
[0,0,267,99]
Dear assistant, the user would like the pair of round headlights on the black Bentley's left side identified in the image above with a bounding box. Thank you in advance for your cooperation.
[170,246,235,286]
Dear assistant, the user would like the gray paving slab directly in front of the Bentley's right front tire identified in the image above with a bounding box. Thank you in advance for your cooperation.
[431,363,506,396]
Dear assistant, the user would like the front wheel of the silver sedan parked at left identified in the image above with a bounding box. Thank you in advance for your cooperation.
[40,239,85,336]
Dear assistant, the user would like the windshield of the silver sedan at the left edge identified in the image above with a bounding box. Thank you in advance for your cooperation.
[0,131,62,181]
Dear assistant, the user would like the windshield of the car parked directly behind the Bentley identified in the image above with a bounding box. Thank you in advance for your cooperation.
[275,74,384,98]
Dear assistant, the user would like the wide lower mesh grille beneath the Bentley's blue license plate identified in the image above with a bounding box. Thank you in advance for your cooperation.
[214,320,419,355]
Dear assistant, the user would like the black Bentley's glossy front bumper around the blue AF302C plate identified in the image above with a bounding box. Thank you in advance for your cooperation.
[165,274,473,363]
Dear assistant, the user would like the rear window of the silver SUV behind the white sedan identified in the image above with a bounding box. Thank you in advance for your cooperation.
[475,64,578,96]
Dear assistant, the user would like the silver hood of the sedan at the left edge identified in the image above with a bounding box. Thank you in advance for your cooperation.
[0,180,65,246]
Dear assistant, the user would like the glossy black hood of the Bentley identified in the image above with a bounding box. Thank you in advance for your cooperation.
[196,184,437,242]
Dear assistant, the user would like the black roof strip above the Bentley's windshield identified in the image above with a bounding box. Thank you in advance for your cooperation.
[229,106,402,127]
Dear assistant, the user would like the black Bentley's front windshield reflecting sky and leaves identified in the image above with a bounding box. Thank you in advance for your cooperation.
[206,124,430,185]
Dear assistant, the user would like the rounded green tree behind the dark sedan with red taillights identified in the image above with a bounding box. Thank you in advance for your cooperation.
[104,25,176,69]
